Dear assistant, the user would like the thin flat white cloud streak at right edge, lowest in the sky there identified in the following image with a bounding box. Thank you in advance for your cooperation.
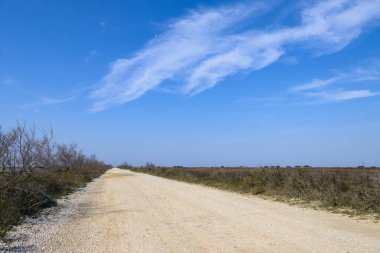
[307,90,380,102]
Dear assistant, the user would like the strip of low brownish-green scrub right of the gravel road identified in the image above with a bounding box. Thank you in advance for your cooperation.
[122,163,380,215]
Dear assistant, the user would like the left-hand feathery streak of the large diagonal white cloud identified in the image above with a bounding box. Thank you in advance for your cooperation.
[93,1,259,111]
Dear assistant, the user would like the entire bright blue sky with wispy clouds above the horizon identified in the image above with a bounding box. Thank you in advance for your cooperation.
[0,0,380,166]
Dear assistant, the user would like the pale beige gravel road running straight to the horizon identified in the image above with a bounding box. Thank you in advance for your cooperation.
[3,168,380,253]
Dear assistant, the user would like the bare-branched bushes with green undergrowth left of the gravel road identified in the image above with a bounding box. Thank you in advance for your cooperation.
[0,123,111,236]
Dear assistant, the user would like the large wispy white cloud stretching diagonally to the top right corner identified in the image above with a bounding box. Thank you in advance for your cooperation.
[93,0,380,111]
